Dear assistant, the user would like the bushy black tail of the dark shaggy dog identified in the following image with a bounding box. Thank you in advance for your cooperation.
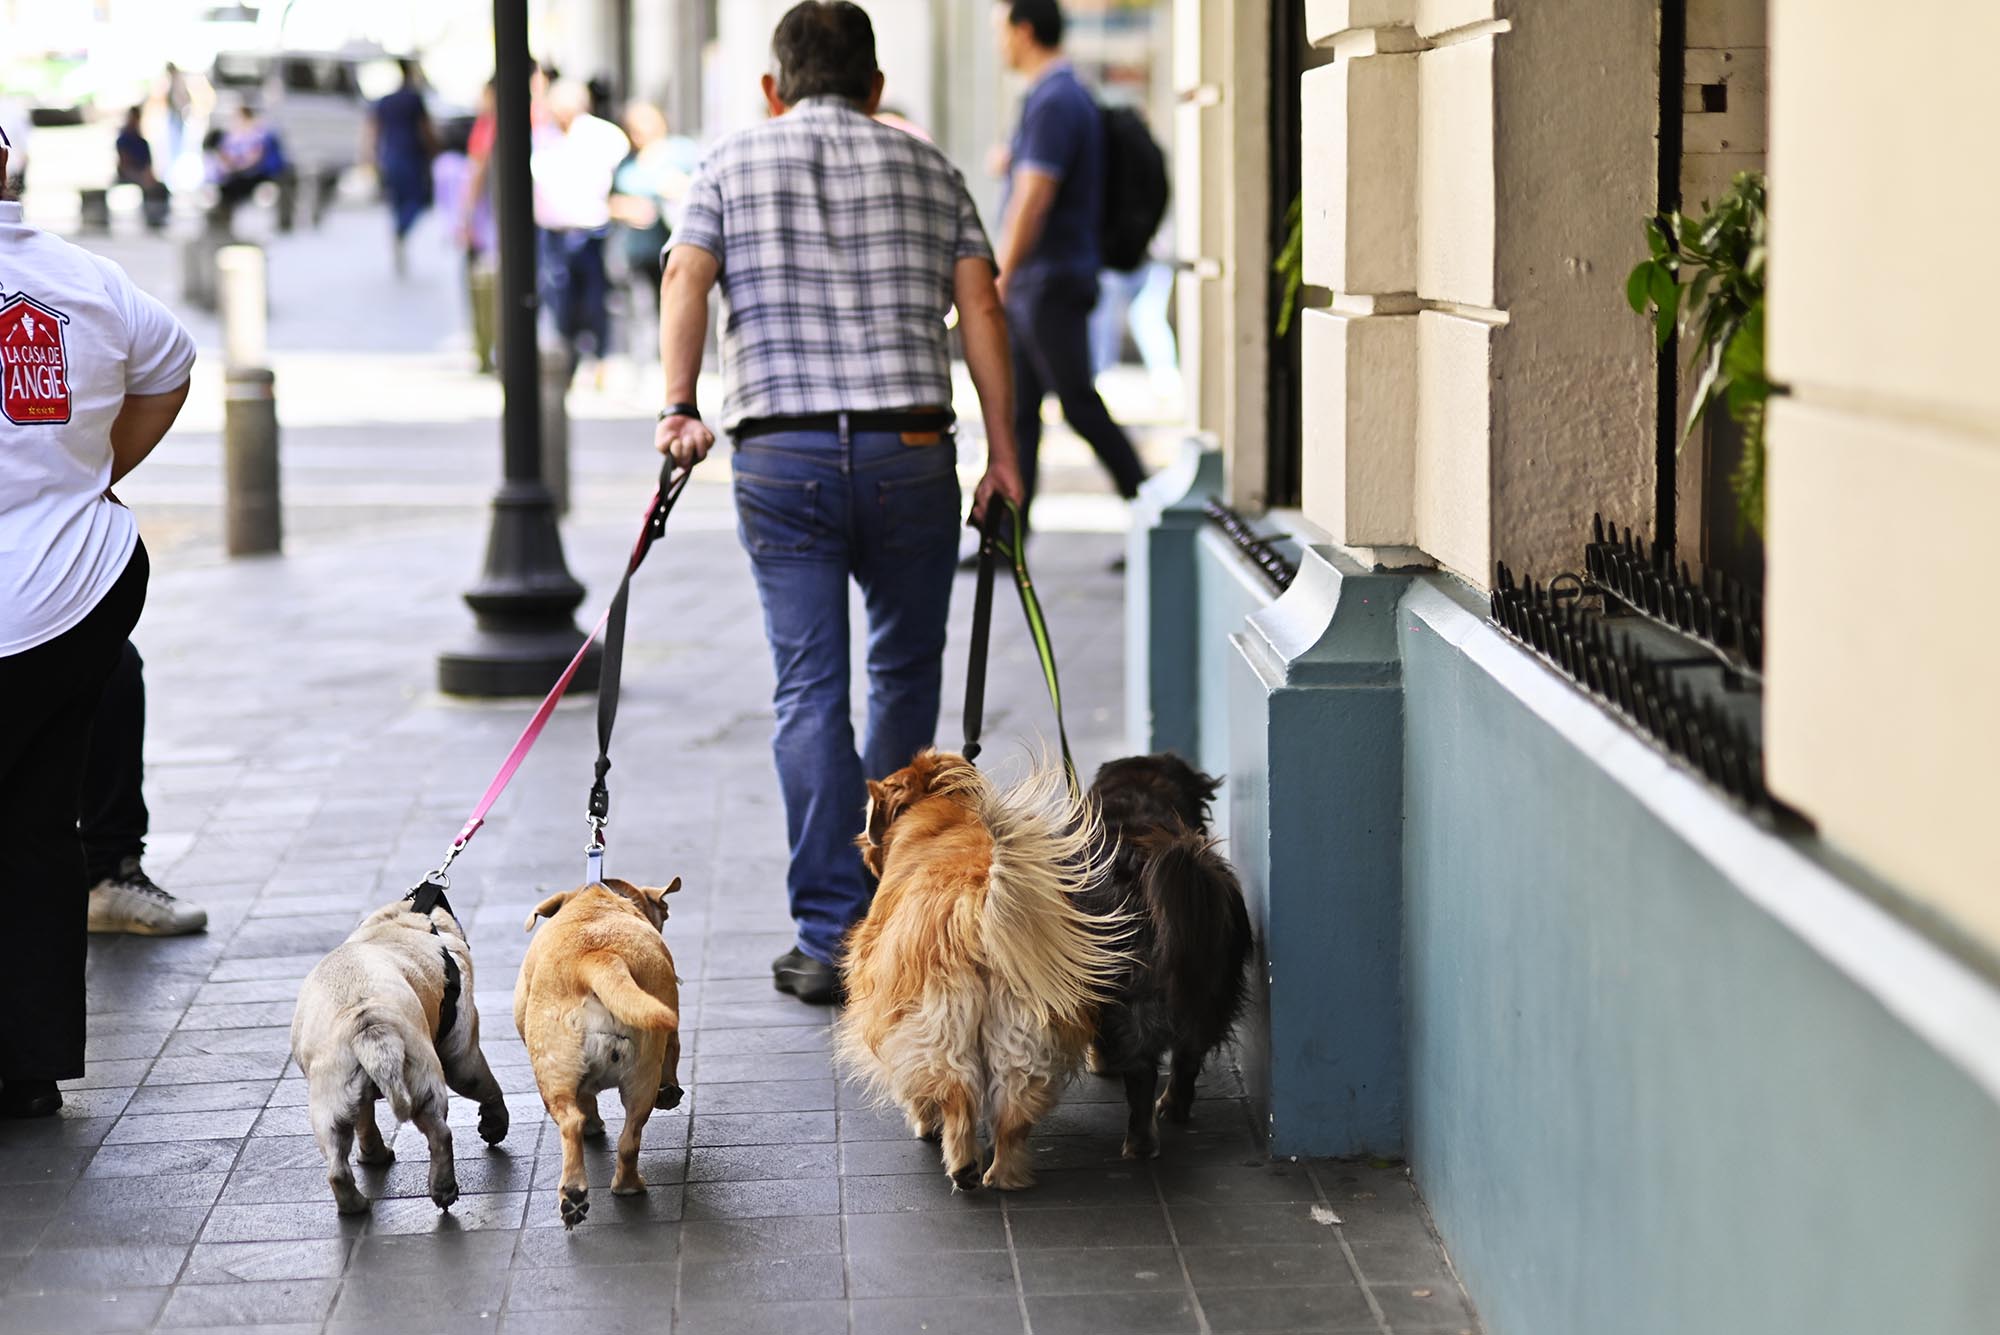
[1140,829,1250,1023]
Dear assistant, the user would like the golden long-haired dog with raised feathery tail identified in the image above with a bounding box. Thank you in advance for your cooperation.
[836,749,1120,1189]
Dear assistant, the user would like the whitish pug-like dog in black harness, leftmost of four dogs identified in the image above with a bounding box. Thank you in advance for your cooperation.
[292,895,508,1215]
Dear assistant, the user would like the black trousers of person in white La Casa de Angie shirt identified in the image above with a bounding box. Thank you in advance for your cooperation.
[0,546,150,1081]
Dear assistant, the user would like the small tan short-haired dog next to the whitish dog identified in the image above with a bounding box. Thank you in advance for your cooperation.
[514,875,680,1229]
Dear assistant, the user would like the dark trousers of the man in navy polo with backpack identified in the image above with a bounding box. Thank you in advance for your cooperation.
[1006,278,1146,519]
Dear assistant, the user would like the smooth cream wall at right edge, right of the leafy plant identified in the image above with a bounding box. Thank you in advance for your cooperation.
[1766,0,2000,949]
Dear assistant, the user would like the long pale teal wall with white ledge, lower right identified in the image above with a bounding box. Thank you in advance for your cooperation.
[1400,578,2000,1335]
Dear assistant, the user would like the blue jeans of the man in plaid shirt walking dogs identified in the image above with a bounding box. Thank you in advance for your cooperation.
[734,432,960,963]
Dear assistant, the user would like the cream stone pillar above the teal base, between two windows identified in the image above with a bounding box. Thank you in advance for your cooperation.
[1302,0,1658,586]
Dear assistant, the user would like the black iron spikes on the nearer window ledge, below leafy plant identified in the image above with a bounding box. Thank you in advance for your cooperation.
[1492,516,1800,823]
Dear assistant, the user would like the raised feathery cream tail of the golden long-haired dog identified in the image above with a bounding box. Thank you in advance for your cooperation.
[974,763,1126,1025]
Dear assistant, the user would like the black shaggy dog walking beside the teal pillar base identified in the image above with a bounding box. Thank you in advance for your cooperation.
[1084,755,1250,1159]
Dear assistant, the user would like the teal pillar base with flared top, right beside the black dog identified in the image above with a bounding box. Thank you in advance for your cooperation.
[1226,548,1408,1155]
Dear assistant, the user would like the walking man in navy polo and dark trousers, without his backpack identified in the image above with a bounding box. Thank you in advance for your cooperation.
[994,0,1146,531]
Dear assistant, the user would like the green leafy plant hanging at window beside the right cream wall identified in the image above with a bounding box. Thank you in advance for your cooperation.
[1626,172,1772,536]
